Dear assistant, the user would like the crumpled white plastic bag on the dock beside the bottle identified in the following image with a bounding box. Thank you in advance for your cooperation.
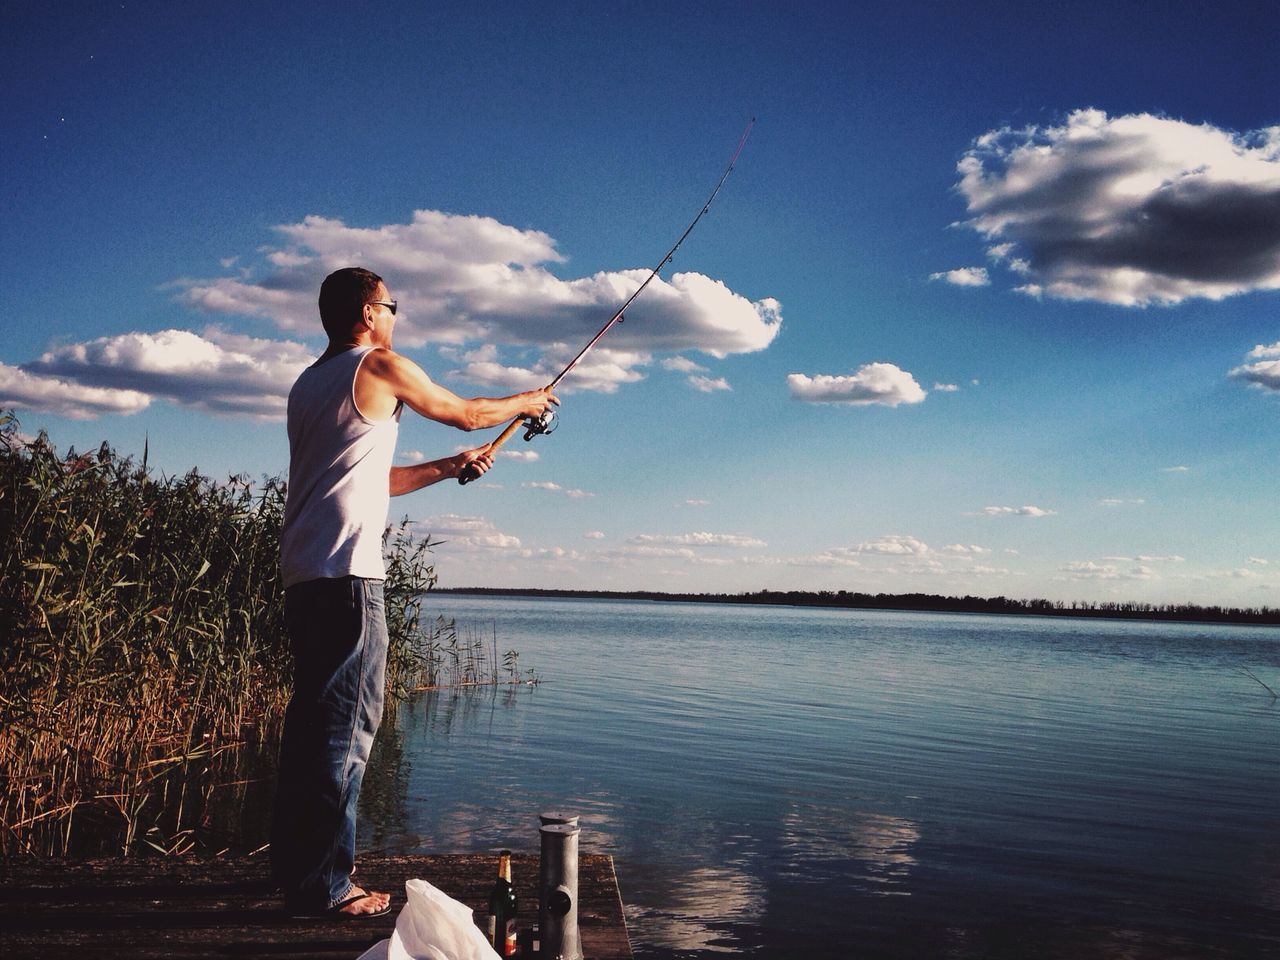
[358,879,499,960]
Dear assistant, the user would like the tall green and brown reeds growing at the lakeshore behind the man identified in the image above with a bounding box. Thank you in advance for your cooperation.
[0,413,494,856]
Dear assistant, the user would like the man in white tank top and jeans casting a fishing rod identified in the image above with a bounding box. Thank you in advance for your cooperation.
[271,268,559,919]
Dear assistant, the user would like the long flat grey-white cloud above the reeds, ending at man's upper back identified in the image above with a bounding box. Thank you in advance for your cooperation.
[22,326,315,420]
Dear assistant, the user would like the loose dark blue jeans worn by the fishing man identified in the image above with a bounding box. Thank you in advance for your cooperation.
[271,577,387,913]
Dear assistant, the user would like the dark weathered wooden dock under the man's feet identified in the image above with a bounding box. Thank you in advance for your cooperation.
[0,854,631,960]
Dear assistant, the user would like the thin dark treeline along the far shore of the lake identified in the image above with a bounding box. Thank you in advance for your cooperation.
[436,588,1280,623]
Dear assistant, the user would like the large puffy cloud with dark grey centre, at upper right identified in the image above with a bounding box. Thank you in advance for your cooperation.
[959,109,1280,306]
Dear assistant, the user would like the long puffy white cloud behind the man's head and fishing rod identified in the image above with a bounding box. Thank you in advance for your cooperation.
[174,210,782,390]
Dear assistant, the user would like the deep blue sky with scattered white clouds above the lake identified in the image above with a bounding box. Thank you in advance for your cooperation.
[0,3,1280,605]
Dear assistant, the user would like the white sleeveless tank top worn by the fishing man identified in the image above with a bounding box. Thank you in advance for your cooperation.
[280,347,403,588]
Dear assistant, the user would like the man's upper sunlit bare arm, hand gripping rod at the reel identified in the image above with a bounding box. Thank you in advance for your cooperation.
[357,349,559,430]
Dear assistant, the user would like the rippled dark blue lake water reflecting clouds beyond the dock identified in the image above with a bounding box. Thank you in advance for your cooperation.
[360,595,1280,960]
